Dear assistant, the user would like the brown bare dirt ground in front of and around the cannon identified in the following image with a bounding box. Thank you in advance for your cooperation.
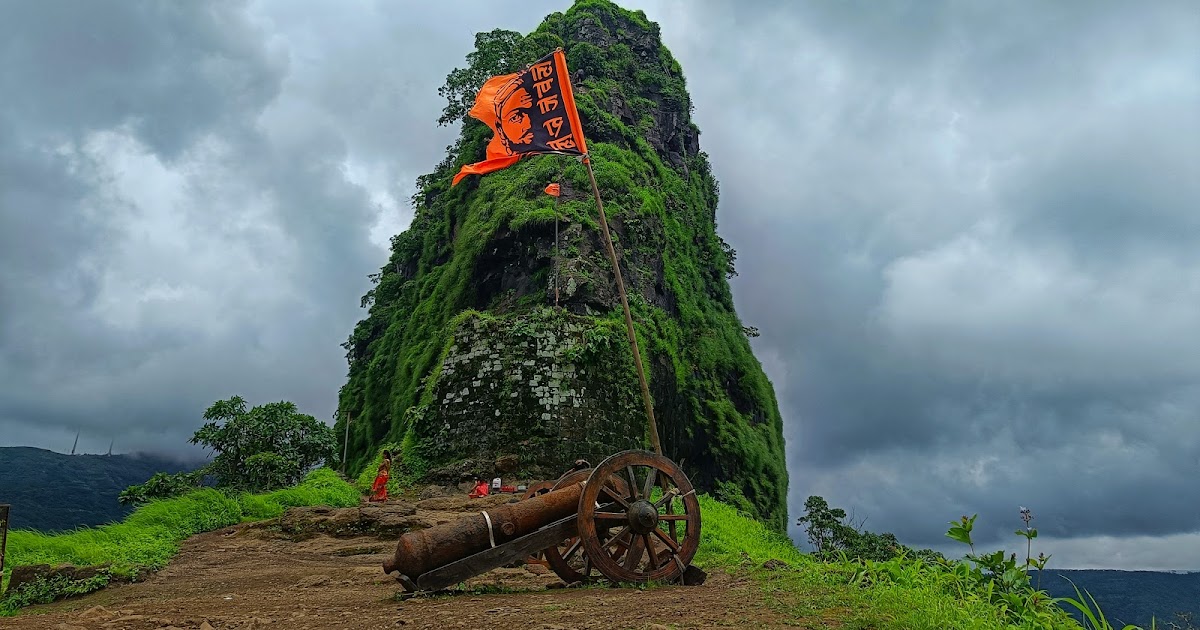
[11,499,788,630]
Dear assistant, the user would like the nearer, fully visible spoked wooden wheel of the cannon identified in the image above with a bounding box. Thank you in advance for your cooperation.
[576,450,700,582]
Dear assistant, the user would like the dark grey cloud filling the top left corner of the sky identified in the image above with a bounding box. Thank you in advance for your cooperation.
[0,1,284,157]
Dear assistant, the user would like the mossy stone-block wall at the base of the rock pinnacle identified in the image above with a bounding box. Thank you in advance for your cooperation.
[412,311,647,482]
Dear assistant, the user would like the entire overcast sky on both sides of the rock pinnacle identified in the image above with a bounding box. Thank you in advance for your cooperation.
[0,0,1200,570]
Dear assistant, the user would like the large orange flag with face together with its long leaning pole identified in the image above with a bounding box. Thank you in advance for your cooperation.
[450,48,662,455]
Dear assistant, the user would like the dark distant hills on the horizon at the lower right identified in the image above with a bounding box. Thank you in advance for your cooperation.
[1033,569,1200,629]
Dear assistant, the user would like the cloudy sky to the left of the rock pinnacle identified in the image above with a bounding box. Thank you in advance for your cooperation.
[0,1,564,451]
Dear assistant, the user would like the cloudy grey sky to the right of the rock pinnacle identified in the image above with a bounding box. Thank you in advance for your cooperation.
[652,2,1200,569]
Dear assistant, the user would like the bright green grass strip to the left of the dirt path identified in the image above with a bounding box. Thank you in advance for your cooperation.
[0,468,360,616]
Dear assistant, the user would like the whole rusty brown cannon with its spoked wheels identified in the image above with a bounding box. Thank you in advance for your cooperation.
[383,450,700,593]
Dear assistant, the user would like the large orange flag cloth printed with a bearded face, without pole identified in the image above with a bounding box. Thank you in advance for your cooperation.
[451,48,588,186]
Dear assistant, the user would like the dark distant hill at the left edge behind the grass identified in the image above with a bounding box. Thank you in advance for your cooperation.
[0,446,199,532]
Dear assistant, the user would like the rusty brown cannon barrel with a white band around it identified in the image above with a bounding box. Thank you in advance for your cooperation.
[383,482,583,578]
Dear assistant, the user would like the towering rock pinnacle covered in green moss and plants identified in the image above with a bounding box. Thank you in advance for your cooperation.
[337,0,787,529]
